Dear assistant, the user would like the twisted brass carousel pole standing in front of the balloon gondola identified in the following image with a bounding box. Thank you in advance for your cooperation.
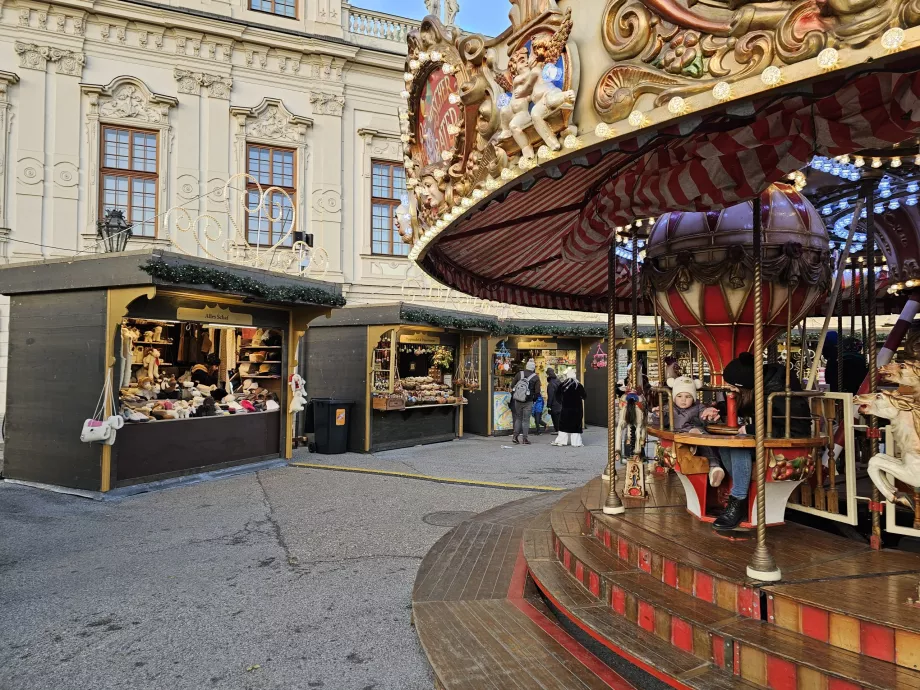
[747,195,788,582]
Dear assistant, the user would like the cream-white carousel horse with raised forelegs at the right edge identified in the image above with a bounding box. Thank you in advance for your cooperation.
[853,391,920,508]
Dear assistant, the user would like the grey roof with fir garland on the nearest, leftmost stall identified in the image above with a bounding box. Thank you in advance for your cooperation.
[0,249,345,307]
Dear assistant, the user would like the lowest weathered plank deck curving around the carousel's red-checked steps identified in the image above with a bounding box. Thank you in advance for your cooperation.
[412,495,648,690]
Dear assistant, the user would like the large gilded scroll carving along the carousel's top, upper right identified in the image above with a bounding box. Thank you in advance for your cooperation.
[594,0,920,122]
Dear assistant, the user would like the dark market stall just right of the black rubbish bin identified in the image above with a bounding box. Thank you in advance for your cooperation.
[306,304,494,452]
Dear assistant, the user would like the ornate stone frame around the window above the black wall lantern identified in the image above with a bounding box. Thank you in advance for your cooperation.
[80,76,179,244]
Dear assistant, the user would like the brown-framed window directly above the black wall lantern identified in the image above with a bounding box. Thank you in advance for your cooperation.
[99,126,157,237]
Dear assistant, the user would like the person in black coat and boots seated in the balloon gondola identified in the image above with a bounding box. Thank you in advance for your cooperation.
[713,352,811,530]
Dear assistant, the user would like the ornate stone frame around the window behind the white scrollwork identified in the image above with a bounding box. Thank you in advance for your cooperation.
[229,98,313,247]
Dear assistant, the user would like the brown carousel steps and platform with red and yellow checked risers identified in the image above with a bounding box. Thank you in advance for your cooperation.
[528,481,920,690]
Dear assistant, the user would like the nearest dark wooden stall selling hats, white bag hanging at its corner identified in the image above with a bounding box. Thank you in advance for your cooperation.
[0,250,344,492]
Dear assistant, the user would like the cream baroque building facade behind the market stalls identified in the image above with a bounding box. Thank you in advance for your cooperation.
[0,0,604,428]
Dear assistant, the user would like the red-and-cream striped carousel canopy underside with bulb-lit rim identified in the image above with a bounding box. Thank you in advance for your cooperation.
[407,2,920,311]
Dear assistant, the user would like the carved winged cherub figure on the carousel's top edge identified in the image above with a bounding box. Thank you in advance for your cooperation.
[497,10,575,158]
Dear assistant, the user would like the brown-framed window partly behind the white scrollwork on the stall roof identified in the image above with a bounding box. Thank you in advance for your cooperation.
[246,144,296,247]
